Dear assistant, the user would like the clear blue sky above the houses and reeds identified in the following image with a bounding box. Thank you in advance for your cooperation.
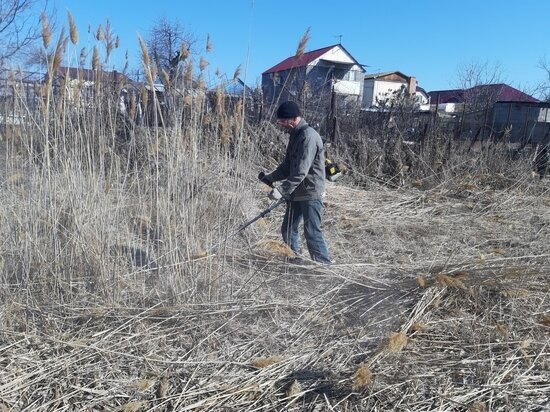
[50,0,550,96]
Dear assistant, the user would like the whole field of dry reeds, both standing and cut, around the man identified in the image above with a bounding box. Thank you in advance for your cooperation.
[0,27,550,412]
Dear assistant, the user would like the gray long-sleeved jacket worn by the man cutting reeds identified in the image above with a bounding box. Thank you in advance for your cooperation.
[267,119,325,200]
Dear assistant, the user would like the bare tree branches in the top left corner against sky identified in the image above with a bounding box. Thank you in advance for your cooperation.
[0,0,48,63]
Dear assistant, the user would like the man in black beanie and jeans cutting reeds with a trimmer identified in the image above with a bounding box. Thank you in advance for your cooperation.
[258,101,332,263]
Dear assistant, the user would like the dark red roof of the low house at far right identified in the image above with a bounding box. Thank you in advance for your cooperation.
[428,83,539,112]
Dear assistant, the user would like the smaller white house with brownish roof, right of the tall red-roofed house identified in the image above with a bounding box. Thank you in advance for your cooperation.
[362,71,429,109]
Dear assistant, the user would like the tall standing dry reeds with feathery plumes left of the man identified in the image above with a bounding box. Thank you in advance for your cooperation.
[0,14,268,305]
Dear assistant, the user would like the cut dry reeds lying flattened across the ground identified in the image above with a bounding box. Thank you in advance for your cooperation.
[0,163,550,411]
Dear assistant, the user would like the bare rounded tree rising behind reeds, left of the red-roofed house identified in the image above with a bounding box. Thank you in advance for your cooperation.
[146,17,196,83]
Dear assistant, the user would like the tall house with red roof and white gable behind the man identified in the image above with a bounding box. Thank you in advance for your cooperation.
[262,44,365,108]
